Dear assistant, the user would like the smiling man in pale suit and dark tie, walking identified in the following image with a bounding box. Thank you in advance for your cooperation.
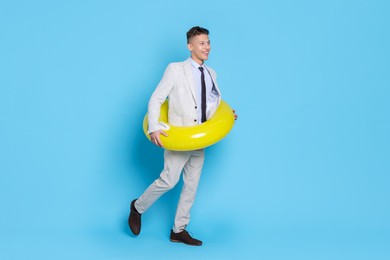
[128,26,236,246]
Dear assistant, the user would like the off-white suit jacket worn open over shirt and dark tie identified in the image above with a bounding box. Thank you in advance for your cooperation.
[148,59,221,134]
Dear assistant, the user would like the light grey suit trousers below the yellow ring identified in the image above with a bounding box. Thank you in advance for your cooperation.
[135,149,204,233]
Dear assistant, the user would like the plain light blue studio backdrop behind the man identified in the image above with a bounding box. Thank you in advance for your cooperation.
[0,0,390,260]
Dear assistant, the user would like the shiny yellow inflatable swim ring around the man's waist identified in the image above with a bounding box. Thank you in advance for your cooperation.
[143,100,234,151]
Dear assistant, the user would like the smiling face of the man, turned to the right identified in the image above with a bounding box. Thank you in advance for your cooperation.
[187,34,211,65]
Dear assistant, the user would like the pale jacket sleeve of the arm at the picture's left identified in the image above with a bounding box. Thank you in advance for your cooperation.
[148,64,174,134]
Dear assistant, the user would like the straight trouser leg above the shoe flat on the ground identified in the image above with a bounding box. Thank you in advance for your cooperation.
[173,149,204,233]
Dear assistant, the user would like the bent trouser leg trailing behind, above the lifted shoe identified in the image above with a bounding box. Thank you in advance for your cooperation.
[135,150,191,214]
